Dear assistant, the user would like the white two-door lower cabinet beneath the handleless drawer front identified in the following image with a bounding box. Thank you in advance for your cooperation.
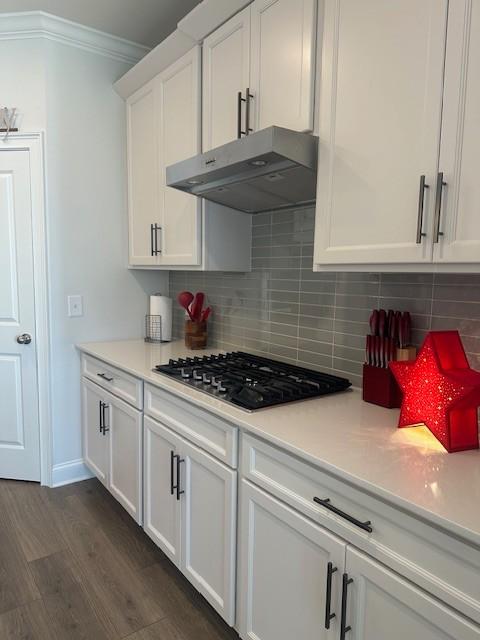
[144,417,237,625]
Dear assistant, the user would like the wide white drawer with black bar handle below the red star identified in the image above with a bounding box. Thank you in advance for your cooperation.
[241,435,480,622]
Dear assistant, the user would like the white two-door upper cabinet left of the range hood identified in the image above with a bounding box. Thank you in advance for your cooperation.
[127,47,201,266]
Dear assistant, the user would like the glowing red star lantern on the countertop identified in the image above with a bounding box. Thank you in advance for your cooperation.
[390,331,480,452]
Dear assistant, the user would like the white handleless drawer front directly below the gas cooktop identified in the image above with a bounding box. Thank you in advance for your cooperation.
[145,384,238,469]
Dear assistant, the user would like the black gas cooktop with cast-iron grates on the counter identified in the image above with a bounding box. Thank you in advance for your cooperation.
[154,351,351,411]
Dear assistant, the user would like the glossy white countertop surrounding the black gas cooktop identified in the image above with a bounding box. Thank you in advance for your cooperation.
[78,340,480,547]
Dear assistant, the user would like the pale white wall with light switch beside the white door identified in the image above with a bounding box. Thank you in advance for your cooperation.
[0,33,168,476]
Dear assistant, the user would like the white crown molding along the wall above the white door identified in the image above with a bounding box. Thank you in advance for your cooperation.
[0,11,150,64]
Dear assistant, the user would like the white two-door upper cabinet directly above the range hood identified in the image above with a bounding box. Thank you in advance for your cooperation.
[203,0,317,151]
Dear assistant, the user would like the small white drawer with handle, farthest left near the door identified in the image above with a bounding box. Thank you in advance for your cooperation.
[82,355,143,409]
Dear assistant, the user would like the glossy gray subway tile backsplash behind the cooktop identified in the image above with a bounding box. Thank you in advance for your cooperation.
[170,209,480,386]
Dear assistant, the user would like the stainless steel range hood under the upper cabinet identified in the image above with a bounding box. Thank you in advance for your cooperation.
[167,127,318,213]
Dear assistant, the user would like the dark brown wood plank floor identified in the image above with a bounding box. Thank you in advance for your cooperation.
[0,480,238,640]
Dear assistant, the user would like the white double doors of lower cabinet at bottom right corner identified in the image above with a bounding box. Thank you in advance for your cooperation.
[238,479,480,640]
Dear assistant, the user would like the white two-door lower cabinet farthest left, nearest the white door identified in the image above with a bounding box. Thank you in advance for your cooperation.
[82,378,143,524]
